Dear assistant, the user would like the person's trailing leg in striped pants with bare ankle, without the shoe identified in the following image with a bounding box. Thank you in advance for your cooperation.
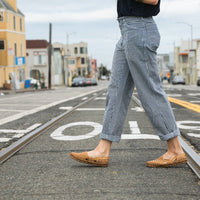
[125,16,186,164]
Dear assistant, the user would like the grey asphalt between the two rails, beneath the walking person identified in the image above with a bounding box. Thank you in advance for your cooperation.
[0,85,200,200]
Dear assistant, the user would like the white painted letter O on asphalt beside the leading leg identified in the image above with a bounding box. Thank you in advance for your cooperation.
[51,122,102,141]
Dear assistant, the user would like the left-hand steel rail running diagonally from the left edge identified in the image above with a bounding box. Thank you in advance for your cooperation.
[0,89,104,164]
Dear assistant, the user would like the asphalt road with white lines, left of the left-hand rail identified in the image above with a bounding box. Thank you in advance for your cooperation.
[0,81,108,150]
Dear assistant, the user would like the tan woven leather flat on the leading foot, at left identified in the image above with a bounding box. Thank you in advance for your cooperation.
[70,152,109,167]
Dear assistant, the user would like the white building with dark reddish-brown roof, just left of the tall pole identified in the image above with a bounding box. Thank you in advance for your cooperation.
[26,40,49,86]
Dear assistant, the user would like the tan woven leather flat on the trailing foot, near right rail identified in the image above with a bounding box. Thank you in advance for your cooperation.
[146,153,187,167]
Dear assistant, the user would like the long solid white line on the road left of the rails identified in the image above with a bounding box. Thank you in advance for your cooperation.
[0,88,106,125]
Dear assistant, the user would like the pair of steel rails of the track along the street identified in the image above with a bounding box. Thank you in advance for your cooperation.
[0,90,200,179]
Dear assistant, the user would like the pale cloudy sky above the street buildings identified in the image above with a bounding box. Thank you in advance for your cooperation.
[17,0,200,69]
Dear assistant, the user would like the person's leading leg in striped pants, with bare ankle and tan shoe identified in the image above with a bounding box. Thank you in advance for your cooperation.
[71,38,134,166]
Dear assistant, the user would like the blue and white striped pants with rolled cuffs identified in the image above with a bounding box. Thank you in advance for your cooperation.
[100,17,180,142]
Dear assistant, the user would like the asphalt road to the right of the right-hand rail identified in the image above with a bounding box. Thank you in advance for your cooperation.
[164,85,200,152]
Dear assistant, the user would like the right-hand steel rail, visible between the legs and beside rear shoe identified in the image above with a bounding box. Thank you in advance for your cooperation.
[132,95,200,179]
